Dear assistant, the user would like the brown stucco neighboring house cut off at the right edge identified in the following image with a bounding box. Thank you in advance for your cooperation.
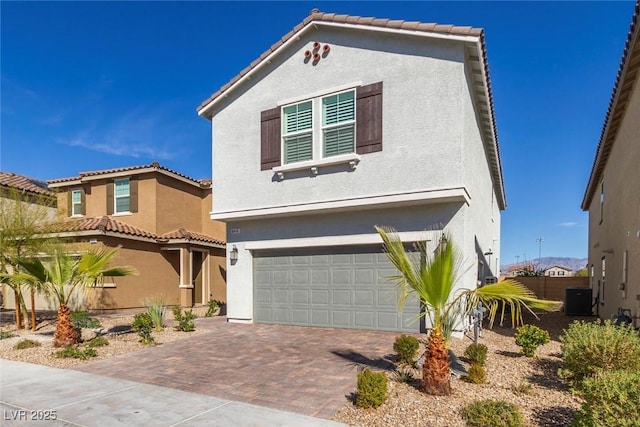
[582,2,640,324]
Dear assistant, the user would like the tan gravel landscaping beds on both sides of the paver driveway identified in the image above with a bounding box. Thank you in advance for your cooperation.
[0,311,585,426]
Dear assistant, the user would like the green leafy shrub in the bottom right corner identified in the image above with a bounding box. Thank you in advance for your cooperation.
[573,371,640,427]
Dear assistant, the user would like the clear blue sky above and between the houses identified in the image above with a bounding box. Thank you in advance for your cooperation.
[0,1,634,264]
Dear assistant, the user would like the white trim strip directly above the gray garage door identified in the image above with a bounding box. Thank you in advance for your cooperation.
[244,230,438,251]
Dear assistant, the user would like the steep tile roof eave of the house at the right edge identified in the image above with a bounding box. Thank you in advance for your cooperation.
[581,0,640,207]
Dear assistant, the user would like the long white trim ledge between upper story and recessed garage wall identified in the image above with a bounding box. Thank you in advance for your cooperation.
[211,187,471,220]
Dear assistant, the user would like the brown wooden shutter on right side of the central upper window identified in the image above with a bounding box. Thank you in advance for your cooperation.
[356,82,382,154]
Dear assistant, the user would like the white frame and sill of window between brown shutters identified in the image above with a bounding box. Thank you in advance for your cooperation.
[282,87,360,167]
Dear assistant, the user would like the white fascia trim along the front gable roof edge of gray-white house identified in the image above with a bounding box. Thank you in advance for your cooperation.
[198,21,480,120]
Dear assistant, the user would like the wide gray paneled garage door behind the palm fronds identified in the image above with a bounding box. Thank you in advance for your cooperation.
[254,246,422,332]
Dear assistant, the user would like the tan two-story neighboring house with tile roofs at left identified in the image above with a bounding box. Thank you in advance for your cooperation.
[40,163,226,309]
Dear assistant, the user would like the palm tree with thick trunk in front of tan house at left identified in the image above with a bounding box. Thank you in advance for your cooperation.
[5,248,136,347]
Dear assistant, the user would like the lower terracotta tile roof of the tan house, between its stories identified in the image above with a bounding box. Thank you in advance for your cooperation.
[49,216,225,246]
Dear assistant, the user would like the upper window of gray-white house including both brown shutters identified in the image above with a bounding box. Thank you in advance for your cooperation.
[260,82,383,170]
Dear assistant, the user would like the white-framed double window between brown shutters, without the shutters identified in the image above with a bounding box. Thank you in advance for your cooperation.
[282,90,356,164]
